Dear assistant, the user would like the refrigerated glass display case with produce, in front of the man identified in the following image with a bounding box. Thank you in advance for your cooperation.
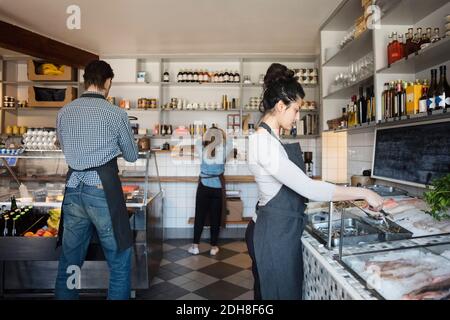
[0,151,163,296]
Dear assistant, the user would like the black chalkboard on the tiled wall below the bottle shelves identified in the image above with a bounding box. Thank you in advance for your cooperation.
[372,121,450,186]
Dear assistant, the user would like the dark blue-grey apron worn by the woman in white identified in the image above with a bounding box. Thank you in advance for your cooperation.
[253,123,307,300]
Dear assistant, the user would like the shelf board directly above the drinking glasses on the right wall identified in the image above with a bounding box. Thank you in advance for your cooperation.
[323,30,373,67]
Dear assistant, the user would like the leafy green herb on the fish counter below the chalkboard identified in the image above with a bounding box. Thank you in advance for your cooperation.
[424,174,450,221]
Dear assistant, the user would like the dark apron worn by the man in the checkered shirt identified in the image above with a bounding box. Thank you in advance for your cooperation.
[57,93,133,252]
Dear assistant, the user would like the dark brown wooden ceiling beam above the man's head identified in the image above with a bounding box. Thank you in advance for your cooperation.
[0,21,99,68]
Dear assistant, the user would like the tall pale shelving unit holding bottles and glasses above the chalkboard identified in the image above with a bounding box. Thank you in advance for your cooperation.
[321,0,450,132]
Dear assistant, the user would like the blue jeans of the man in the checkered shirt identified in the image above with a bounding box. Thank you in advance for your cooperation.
[55,183,131,300]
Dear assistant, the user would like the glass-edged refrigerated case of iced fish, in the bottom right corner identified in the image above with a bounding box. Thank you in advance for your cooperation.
[340,235,450,300]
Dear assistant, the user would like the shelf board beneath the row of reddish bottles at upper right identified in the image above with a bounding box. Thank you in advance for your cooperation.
[377,37,450,74]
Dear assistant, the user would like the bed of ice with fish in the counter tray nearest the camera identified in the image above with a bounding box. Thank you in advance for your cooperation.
[343,248,450,300]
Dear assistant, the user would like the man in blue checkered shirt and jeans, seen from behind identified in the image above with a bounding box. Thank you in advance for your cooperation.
[55,61,138,300]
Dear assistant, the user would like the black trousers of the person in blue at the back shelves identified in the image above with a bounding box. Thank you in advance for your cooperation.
[194,183,222,246]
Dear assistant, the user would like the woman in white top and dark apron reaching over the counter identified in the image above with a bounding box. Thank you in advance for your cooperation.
[246,64,383,300]
